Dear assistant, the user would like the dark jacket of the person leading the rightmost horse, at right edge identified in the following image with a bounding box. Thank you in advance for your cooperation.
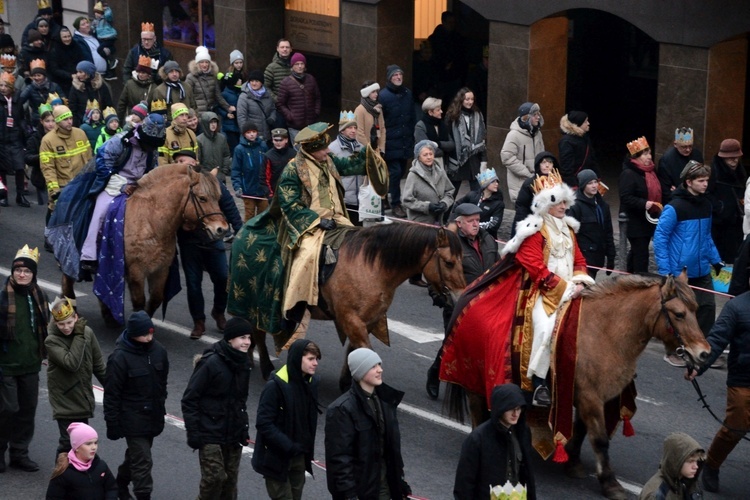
[698,292,750,387]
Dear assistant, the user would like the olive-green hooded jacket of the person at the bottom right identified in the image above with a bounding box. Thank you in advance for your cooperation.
[638,432,705,500]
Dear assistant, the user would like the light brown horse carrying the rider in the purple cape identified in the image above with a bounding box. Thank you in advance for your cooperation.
[62,164,229,326]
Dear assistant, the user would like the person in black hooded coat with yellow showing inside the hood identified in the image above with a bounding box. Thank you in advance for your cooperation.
[253,339,321,500]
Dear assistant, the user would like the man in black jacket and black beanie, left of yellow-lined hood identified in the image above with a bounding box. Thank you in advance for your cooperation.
[182,318,253,499]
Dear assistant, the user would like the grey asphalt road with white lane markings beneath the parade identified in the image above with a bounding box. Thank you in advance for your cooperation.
[0,195,750,500]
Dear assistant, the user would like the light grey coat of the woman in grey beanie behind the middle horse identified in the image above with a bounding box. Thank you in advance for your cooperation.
[401,159,455,224]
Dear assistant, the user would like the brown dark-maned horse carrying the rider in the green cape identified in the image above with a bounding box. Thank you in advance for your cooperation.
[254,223,466,392]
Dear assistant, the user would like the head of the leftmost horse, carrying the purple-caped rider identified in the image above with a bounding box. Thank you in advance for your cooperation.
[182,166,229,241]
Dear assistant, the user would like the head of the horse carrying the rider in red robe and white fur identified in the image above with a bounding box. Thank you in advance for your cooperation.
[654,269,711,366]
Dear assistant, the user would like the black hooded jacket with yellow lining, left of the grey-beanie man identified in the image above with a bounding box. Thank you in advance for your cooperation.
[252,340,320,482]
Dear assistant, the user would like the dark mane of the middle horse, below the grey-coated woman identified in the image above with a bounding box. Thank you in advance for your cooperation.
[341,223,462,270]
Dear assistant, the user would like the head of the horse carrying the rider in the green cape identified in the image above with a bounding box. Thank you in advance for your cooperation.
[422,227,466,303]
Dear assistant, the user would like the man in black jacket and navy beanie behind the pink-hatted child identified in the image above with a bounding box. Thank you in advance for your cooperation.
[104,311,169,500]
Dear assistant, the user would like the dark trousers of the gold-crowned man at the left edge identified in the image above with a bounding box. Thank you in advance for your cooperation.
[0,372,39,461]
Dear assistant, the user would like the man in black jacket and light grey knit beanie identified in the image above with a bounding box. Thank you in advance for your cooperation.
[325,347,411,500]
